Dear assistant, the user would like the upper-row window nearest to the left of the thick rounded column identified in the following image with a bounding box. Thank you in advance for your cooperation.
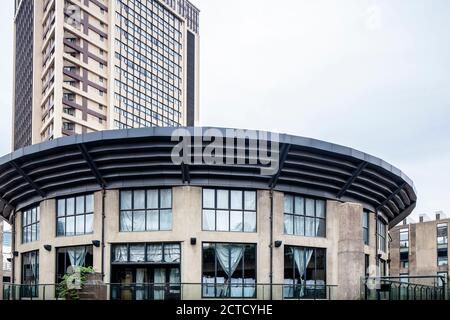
[284,195,326,237]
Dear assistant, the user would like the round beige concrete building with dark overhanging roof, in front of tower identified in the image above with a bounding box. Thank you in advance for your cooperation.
[0,128,416,300]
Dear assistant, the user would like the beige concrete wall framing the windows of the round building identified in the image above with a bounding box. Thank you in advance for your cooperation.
[15,186,382,299]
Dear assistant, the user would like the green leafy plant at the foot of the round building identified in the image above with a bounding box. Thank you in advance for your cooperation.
[57,267,95,300]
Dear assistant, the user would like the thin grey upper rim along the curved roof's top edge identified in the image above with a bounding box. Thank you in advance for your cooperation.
[0,127,417,228]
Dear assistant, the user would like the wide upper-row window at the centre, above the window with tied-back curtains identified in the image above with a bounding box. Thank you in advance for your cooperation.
[202,189,256,232]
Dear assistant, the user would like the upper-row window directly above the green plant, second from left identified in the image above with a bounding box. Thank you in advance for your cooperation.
[57,194,94,237]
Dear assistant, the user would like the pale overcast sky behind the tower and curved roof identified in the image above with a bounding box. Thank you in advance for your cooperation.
[0,0,450,220]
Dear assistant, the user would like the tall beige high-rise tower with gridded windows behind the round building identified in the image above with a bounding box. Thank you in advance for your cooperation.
[13,0,199,149]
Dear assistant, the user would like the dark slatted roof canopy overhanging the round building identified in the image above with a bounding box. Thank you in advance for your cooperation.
[0,128,417,227]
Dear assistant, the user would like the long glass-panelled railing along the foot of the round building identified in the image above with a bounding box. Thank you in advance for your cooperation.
[3,283,337,300]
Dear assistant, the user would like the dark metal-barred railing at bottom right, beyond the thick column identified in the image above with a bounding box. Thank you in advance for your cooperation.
[361,276,449,300]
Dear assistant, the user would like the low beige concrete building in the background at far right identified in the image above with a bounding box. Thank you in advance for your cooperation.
[390,214,450,285]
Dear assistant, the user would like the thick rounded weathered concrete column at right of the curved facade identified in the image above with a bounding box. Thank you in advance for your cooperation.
[336,203,364,300]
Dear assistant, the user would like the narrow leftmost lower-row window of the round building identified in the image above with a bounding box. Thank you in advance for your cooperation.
[21,251,39,298]
